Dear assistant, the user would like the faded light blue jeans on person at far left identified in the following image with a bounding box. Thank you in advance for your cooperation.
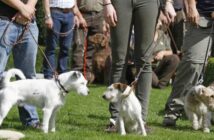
[0,18,39,125]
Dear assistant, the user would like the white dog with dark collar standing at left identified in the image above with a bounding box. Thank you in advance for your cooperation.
[0,69,89,133]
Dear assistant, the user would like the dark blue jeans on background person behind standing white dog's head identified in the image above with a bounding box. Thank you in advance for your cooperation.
[43,9,74,79]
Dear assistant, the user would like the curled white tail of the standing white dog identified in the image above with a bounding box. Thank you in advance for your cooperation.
[1,68,26,86]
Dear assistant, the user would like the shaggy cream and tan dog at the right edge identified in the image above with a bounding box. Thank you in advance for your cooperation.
[184,85,214,133]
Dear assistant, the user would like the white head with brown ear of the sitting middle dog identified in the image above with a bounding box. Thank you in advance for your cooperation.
[103,83,131,102]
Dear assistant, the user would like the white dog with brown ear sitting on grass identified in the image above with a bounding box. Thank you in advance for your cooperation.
[103,83,147,136]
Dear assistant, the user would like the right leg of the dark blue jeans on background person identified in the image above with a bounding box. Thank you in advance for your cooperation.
[57,12,74,73]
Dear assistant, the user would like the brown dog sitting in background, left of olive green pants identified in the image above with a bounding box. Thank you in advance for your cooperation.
[89,33,111,84]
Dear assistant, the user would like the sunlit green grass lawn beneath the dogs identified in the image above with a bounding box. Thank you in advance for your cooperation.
[2,85,214,140]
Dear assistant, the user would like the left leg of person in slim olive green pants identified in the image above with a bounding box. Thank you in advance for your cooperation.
[109,0,133,126]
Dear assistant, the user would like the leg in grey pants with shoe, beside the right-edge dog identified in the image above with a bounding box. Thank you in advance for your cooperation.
[163,20,212,126]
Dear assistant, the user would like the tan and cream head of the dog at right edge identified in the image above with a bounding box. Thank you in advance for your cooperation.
[193,85,214,111]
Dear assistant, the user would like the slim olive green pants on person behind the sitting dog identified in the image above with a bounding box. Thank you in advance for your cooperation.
[109,0,159,120]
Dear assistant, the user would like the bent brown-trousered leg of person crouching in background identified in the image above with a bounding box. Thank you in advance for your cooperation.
[155,54,180,88]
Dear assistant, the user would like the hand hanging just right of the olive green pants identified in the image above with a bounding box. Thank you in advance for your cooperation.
[164,1,176,23]
